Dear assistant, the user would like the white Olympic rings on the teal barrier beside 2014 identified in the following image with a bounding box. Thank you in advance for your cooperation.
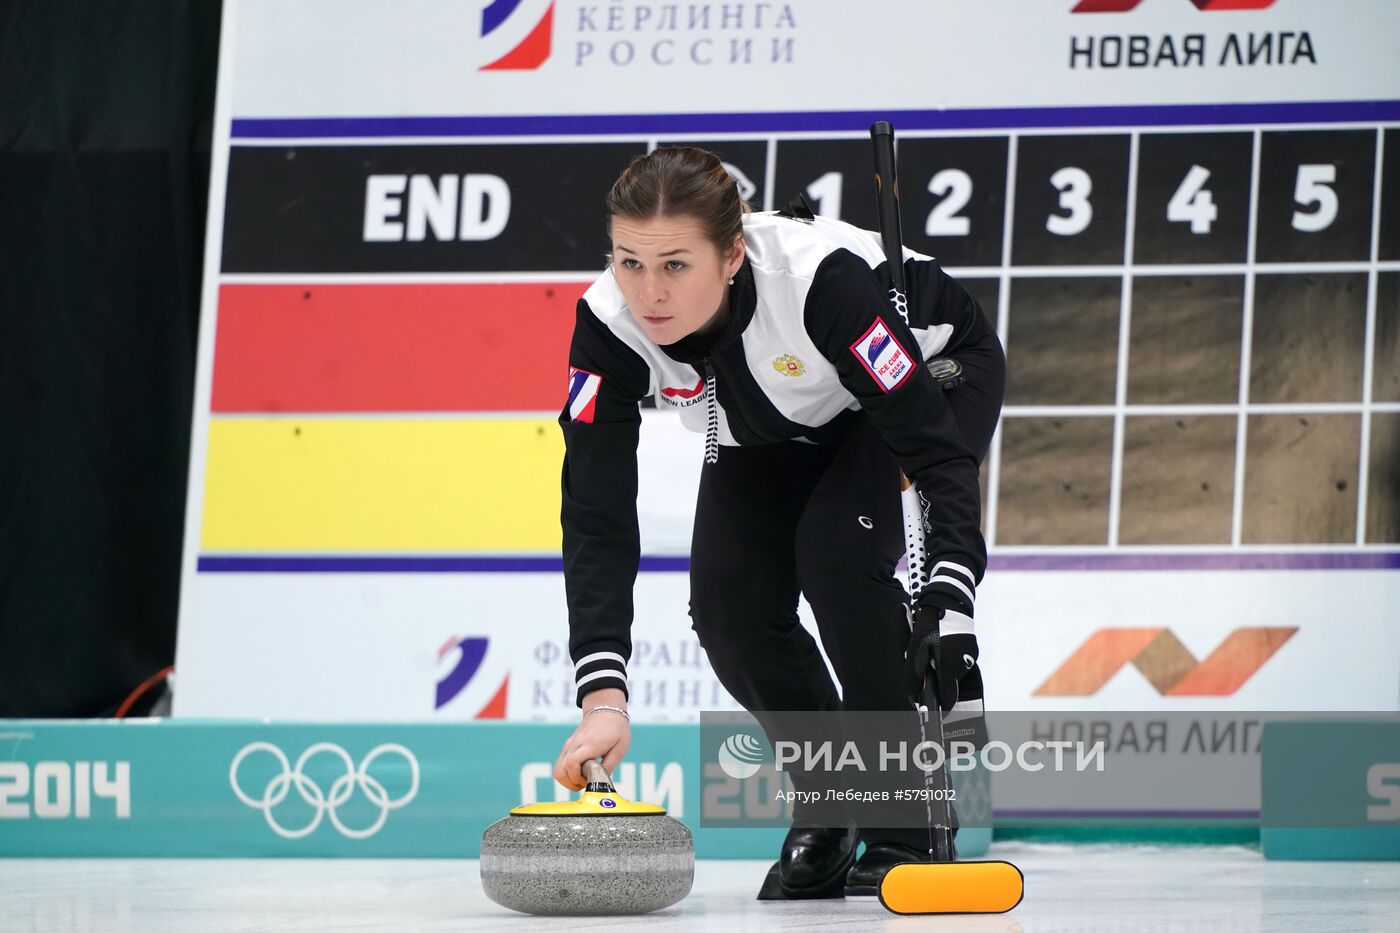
[228,742,419,839]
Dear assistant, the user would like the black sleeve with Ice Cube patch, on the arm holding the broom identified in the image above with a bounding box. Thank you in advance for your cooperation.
[804,249,987,615]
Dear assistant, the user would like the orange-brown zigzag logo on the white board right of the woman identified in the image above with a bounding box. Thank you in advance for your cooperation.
[1035,628,1298,696]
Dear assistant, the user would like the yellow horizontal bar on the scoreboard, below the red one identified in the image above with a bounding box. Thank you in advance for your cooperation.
[200,417,564,551]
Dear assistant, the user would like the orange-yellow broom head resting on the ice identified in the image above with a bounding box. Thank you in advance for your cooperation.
[879,862,1025,913]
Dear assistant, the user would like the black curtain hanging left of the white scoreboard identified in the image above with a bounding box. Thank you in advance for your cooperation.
[0,0,220,717]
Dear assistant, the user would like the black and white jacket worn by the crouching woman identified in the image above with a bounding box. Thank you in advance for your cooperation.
[560,213,991,705]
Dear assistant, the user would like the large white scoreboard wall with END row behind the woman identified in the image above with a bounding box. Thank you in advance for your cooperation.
[175,0,1400,717]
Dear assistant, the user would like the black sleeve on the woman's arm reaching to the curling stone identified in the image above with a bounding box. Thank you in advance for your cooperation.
[559,298,650,706]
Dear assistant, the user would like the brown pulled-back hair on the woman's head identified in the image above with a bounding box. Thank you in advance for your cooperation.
[608,146,752,254]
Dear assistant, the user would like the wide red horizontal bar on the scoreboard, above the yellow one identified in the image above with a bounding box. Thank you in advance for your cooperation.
[211,282,588,412]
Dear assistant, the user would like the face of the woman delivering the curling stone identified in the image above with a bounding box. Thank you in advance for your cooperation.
[612,214,743,346]
